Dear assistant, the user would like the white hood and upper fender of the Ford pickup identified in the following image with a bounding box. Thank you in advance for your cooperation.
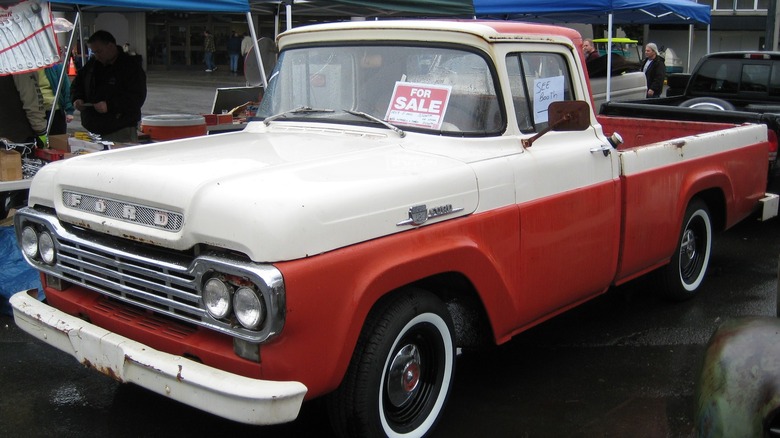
[30,123,478,262]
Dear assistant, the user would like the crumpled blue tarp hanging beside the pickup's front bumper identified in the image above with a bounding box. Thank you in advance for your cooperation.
[0,227,43,315]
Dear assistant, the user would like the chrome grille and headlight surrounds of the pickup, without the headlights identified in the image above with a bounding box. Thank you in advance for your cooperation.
[14,207,285,343]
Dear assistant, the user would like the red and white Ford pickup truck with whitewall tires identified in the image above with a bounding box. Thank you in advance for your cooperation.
[11,21,777,436]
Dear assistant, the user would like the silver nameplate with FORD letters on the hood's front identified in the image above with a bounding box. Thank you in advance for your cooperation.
[62,191,184,231]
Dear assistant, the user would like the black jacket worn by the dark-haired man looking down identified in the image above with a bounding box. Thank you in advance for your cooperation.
[70,48,146,134]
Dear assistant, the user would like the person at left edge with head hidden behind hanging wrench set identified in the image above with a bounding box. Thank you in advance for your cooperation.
[0,72,47,147]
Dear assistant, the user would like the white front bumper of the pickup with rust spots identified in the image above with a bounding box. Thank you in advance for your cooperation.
[10,292,307,425]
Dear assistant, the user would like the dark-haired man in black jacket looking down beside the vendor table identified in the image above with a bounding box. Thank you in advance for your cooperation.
[71,30,146,143]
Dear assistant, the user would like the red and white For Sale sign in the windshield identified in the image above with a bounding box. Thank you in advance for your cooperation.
[385,82,452,129]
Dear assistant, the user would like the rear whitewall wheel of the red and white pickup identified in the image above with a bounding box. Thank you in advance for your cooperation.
[659,200,712,301]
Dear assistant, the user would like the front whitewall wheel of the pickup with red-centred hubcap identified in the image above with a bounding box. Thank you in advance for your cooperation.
[328,289,455,437]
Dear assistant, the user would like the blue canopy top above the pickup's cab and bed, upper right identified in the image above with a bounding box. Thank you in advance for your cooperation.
[474,0,710,24]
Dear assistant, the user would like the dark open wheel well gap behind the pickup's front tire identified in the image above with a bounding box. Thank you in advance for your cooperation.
[410,272,495,349]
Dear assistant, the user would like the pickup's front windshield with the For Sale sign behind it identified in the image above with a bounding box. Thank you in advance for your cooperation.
[257,45,506,135]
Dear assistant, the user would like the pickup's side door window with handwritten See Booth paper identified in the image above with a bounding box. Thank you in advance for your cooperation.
[506,52,573,132]
